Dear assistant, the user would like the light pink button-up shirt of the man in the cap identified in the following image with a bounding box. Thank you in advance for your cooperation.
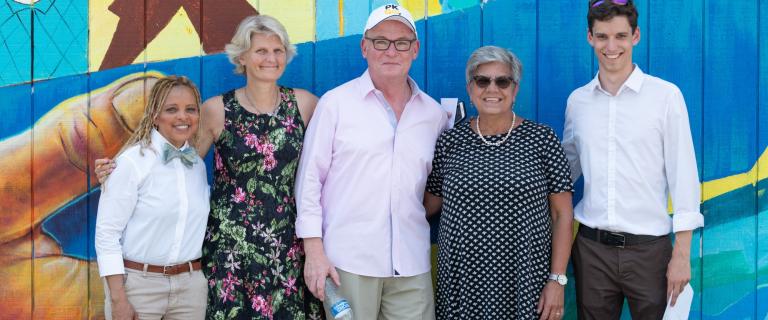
[296,71,447,277]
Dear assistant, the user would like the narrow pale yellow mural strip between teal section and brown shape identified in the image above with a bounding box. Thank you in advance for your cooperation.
[88,0,119,71]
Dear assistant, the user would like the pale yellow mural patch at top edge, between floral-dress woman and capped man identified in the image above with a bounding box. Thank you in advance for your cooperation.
[258,0,315,44]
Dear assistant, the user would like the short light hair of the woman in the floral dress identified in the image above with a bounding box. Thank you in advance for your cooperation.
[224,14,296,74]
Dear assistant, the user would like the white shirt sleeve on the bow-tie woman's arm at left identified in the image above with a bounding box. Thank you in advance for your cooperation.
[95,157,139,277]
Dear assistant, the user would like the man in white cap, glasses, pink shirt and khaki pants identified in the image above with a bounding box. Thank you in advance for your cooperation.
[296,4,447,319]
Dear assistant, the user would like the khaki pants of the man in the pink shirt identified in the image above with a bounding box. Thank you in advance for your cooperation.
[325,268,435,320]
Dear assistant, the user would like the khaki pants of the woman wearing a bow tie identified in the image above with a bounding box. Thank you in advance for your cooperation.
[102,268,208,320]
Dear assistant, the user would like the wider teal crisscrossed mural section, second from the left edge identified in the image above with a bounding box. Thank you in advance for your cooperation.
[33,0,88,79]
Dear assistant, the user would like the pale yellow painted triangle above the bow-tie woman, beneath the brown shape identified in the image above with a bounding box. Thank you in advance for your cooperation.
[133,8,202,63]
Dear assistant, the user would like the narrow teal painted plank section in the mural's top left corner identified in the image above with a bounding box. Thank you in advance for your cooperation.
[0,1,32,86]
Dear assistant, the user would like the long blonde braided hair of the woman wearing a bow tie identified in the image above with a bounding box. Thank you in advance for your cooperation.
[117,76,202,155]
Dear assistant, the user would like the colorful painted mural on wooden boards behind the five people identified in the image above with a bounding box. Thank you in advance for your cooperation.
[0,0,768,320]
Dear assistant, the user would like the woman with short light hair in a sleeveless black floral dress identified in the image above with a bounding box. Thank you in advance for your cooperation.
[96,15,323,319]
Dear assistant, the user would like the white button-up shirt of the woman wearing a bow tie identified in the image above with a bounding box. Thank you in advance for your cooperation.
[95,130,209,277]
